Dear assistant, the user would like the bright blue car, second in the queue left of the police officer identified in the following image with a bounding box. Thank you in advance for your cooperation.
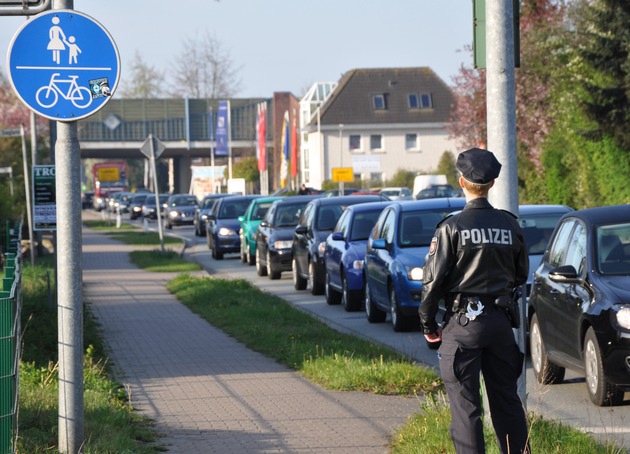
[324,202,391,311]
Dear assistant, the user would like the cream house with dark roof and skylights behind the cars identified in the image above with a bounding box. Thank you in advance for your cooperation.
[300,67,457,188]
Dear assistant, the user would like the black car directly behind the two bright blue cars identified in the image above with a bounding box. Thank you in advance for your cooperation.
[291,195,382,295]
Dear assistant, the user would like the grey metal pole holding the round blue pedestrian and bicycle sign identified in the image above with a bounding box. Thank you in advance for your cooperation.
[53,0,84,454]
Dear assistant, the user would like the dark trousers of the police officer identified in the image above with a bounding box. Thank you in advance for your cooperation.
[438,305,529,454]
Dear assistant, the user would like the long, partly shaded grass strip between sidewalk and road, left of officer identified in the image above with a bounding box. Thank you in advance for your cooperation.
[168,275,442,396]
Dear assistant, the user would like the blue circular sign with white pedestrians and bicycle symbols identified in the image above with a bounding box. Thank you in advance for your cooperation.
[7,10,120,121]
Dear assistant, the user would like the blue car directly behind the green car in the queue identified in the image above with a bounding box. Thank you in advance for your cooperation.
[206,195,260,260]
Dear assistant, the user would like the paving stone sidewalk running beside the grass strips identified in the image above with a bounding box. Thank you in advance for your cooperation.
[83,229,419,454]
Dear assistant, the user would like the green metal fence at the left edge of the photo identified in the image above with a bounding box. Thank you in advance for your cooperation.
[0,222,22,454]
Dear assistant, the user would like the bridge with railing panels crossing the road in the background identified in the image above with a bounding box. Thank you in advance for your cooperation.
[78,98,274,192]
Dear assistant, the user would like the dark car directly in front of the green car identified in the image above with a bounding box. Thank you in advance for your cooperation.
[256,195,319,279]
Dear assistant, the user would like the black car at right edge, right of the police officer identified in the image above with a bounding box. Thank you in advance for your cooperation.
[529,205,630,406]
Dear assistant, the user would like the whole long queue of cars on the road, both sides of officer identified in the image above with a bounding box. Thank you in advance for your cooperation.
[111,186,630,406]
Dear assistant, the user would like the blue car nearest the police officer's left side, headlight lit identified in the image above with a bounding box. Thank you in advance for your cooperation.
[364,197,466,332]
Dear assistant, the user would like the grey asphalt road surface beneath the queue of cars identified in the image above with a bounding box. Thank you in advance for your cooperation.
[106,217,630,453]
